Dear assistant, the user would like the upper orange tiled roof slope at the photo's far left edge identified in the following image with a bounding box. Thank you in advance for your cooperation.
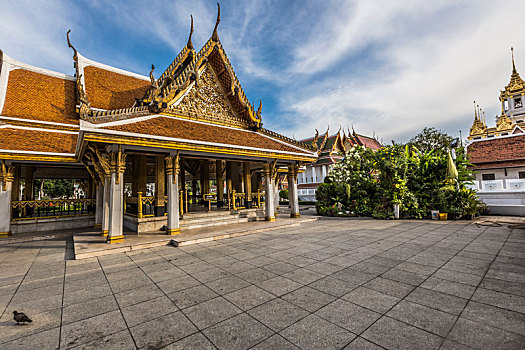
[0,68,79,125]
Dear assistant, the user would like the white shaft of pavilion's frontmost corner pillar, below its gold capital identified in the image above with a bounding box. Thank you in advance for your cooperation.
[107,171,124,243]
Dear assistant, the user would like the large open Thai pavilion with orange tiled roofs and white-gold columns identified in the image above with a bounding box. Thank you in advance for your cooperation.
[0,8,317,243]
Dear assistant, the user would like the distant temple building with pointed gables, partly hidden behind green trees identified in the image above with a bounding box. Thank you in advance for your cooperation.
[298,128,381,200]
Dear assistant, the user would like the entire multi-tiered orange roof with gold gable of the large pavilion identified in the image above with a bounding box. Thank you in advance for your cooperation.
[0,5,317,162]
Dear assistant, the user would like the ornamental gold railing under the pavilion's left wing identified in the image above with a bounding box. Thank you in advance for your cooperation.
[11,198,96,220]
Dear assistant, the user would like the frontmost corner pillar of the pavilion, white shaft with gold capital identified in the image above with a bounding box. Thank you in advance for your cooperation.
[107,146,126,243]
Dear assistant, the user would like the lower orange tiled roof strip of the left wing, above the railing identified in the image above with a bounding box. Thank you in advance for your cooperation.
[0,128,78,153]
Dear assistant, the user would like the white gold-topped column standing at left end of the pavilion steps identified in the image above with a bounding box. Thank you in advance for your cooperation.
[166,154,180,235]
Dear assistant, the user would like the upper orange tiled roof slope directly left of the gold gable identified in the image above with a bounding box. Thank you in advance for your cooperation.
[84,66,151,109]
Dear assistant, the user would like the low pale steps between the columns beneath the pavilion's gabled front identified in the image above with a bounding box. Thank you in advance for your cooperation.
[180,209,264,229]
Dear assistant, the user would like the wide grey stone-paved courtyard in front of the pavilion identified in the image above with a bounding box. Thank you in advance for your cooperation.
[0,219,525,350]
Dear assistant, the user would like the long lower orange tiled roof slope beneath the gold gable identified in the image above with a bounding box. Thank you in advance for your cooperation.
[100,116,309,153]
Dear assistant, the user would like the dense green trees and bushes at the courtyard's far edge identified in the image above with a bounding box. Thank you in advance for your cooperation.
[316,145,485,219]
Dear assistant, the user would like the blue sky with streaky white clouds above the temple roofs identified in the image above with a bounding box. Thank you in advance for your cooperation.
[0,0,525,142]
